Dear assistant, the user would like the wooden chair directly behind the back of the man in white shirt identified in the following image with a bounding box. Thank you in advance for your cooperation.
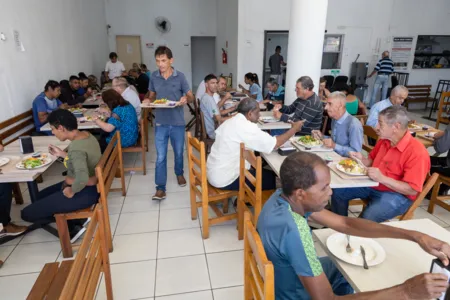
[237,143,275,240]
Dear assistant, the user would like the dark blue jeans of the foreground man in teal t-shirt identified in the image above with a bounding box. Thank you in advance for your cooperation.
[297,257,354,299]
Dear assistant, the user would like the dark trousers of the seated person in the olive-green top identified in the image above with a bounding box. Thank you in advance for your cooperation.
[22,182,99,230]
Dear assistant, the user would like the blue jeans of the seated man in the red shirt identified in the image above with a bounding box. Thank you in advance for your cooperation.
[331,187,412,223]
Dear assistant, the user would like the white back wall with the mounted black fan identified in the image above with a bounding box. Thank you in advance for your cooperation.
[106,0,217,87]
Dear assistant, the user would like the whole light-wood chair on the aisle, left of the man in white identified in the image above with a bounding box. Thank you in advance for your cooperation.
[186,132,238,239]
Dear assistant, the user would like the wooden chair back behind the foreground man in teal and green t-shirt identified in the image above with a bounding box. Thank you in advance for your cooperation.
[244,212,275,300]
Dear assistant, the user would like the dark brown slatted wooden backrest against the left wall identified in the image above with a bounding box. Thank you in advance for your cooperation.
[0,109,36,146]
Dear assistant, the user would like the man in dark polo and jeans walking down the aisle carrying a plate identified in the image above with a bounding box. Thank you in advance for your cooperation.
[143,46,194,200]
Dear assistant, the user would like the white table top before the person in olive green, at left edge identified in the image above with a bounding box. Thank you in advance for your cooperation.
[0,136,70,183]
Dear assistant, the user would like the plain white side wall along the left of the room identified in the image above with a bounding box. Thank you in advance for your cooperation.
[0,0,108,121]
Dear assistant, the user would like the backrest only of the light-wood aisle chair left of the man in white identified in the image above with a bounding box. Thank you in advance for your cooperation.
[186,132,208,197]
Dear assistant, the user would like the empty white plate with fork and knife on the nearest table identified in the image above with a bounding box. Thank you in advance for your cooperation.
[327,232,386,267]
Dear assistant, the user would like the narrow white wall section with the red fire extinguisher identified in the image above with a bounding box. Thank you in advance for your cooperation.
[216,0,239,87]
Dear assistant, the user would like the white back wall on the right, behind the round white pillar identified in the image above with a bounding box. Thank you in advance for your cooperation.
[238,0,450,97]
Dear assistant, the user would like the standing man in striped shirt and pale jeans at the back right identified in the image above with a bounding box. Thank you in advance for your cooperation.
[367,51,394,107]
